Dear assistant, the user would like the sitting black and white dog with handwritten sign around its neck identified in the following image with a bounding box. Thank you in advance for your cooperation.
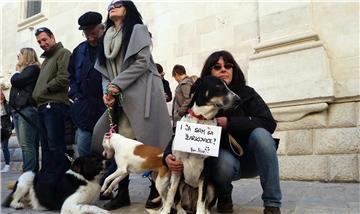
[161,76,239,214]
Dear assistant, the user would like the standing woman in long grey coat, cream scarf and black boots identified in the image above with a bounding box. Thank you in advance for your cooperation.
[92,0,173,210]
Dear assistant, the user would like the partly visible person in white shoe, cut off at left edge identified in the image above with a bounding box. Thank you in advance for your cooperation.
[0,88,13,172]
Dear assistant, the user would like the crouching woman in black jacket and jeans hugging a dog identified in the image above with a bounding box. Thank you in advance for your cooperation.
[200,51,281,213]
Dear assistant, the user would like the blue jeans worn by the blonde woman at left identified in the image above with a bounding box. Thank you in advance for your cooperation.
[13,106,39,172]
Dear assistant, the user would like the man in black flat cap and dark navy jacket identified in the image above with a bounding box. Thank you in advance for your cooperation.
[68,11,105,156]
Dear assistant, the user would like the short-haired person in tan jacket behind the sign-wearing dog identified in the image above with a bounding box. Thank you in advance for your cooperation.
[172,65,194,131]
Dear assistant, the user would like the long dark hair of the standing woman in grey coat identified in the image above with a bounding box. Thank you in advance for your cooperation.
[98,1,143,65]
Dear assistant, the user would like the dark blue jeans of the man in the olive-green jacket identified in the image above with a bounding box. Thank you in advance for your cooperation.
[38,103,69,172]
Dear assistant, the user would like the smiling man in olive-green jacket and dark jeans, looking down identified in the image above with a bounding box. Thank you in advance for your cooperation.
[32,27,71,173]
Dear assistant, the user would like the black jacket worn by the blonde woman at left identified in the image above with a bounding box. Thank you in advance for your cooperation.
[9,65,40,110]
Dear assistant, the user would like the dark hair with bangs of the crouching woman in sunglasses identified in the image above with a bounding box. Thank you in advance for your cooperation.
[200,50,246,90]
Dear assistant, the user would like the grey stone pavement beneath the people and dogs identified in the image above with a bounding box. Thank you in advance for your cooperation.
[1,171,360,214]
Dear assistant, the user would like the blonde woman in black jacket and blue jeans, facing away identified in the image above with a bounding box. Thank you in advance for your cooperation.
[9,48,40,172]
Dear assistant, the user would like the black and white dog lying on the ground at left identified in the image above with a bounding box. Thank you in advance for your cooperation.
[2,155,109,214]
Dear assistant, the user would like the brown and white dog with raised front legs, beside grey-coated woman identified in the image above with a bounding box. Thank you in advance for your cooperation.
[101,133,170,207]
